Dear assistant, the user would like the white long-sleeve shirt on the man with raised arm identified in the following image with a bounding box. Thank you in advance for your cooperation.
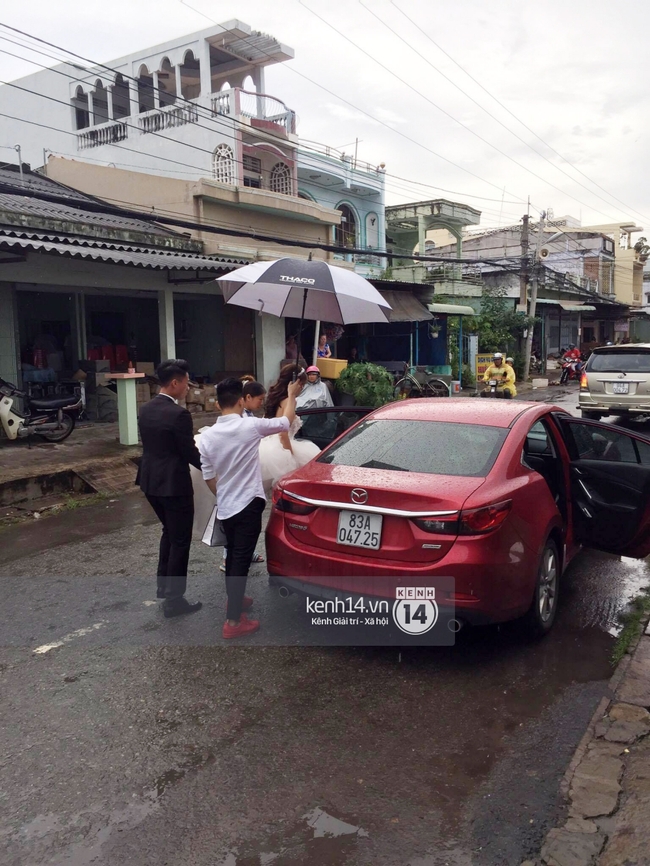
[199,414,290,520]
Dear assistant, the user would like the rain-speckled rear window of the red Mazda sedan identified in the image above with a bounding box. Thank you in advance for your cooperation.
[318,418,508,477]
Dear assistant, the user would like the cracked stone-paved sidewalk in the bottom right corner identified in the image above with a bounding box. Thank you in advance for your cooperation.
[522,625,650,866]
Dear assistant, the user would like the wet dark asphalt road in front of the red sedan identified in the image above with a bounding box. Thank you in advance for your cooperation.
[0,394,649,866]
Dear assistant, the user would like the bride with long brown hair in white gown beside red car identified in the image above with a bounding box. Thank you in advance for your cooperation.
[260,364,320,496]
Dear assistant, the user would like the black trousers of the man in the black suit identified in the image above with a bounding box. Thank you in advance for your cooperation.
[147,495,194,602]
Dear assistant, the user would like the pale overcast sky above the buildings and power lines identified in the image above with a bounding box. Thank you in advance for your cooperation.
[0,0,650,232]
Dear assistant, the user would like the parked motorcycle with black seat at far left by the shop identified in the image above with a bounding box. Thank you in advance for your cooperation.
[0,379,83,442]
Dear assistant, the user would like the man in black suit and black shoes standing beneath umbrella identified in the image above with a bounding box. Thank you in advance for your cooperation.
[135,358,201,617]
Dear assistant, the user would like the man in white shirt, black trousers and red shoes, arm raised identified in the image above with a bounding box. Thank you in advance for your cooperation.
[199,378,302,638]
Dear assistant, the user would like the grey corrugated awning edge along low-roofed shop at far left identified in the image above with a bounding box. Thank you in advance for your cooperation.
[0,232,245,272]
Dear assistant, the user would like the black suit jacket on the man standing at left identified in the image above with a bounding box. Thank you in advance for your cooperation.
[135,394,201,496]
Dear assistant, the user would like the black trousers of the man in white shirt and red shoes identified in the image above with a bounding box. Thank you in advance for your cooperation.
[221,496,266,621]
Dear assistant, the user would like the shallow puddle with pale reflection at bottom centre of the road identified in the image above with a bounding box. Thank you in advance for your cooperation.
[217,808,369,866]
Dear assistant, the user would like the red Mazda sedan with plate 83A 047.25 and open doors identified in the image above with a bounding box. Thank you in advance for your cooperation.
[266,398,650,634]
